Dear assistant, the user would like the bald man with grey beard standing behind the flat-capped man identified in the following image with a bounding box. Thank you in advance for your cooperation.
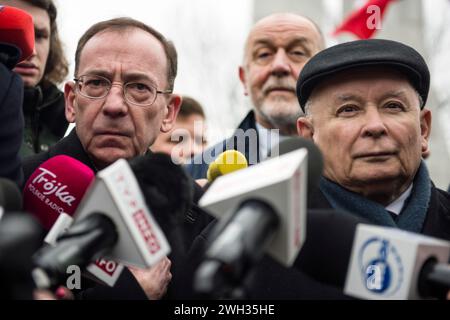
[187,13,325,179]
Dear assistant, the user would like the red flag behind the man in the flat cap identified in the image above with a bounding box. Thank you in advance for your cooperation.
[333,0,395,39]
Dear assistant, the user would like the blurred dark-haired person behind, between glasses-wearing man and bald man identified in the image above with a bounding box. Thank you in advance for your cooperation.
[151,96,207,163]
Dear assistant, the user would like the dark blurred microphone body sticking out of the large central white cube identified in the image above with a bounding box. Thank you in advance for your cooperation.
[194,199,280,297]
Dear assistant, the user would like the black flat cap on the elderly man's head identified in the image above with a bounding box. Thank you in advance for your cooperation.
[297,39,430,112]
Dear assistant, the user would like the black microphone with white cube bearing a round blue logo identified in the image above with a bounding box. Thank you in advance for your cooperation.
[295,210,450,299]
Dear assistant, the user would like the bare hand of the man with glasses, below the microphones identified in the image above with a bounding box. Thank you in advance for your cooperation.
[129,257,172,300]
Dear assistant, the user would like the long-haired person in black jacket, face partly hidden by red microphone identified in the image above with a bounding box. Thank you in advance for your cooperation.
[0,0,68,157]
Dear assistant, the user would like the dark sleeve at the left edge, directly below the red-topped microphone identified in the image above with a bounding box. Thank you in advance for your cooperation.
[0,52,24,185]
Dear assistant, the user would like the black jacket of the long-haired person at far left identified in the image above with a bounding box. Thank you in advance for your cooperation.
[20,84,69,157]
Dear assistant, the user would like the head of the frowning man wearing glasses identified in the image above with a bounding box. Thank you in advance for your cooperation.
[64,19,181,169]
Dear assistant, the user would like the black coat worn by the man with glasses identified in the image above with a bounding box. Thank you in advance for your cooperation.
[23,130,212,300]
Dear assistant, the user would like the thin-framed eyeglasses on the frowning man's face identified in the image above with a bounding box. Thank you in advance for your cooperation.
[73,75,172,107]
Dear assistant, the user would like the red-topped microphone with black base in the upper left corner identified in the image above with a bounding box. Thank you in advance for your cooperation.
[0,5,34,68]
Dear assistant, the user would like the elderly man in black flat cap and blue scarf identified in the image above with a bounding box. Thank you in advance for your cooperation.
[297,39,450,240]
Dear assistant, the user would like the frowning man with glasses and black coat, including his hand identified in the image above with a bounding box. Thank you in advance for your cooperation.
[24,18,213,299]
